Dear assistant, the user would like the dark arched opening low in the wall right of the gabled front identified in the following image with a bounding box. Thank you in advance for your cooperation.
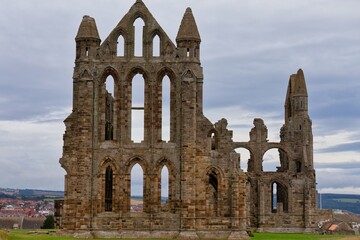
[206,171,219,217]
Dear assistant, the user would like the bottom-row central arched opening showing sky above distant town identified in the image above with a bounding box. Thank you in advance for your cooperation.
[130,163,144,212]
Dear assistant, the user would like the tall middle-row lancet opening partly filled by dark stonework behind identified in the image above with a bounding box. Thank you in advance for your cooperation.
[105,75,115,140]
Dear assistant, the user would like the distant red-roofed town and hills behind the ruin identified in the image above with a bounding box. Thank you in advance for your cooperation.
[0,188,360,232]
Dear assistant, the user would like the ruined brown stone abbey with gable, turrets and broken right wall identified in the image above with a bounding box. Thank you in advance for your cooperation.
[60,0,317,239]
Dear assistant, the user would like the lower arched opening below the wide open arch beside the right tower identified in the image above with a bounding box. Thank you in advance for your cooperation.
[271,181,289,213]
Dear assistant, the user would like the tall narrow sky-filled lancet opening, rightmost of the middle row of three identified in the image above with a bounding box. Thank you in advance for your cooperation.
[161,75,170,141]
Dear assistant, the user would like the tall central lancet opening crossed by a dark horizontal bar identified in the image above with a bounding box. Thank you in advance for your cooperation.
[131,74,145,143]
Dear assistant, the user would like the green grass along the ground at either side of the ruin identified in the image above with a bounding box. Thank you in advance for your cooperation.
[0,230,360,240]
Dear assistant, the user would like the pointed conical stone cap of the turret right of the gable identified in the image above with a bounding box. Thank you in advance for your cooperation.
[176,7,201,42]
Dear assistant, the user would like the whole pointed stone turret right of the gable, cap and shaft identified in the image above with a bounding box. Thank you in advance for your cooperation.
[176,8,201,61]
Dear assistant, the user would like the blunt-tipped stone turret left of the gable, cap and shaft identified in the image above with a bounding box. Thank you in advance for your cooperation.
[75,15,101,60]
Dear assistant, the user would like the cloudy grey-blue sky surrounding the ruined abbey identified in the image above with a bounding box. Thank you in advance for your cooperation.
[0,0,360,194]
